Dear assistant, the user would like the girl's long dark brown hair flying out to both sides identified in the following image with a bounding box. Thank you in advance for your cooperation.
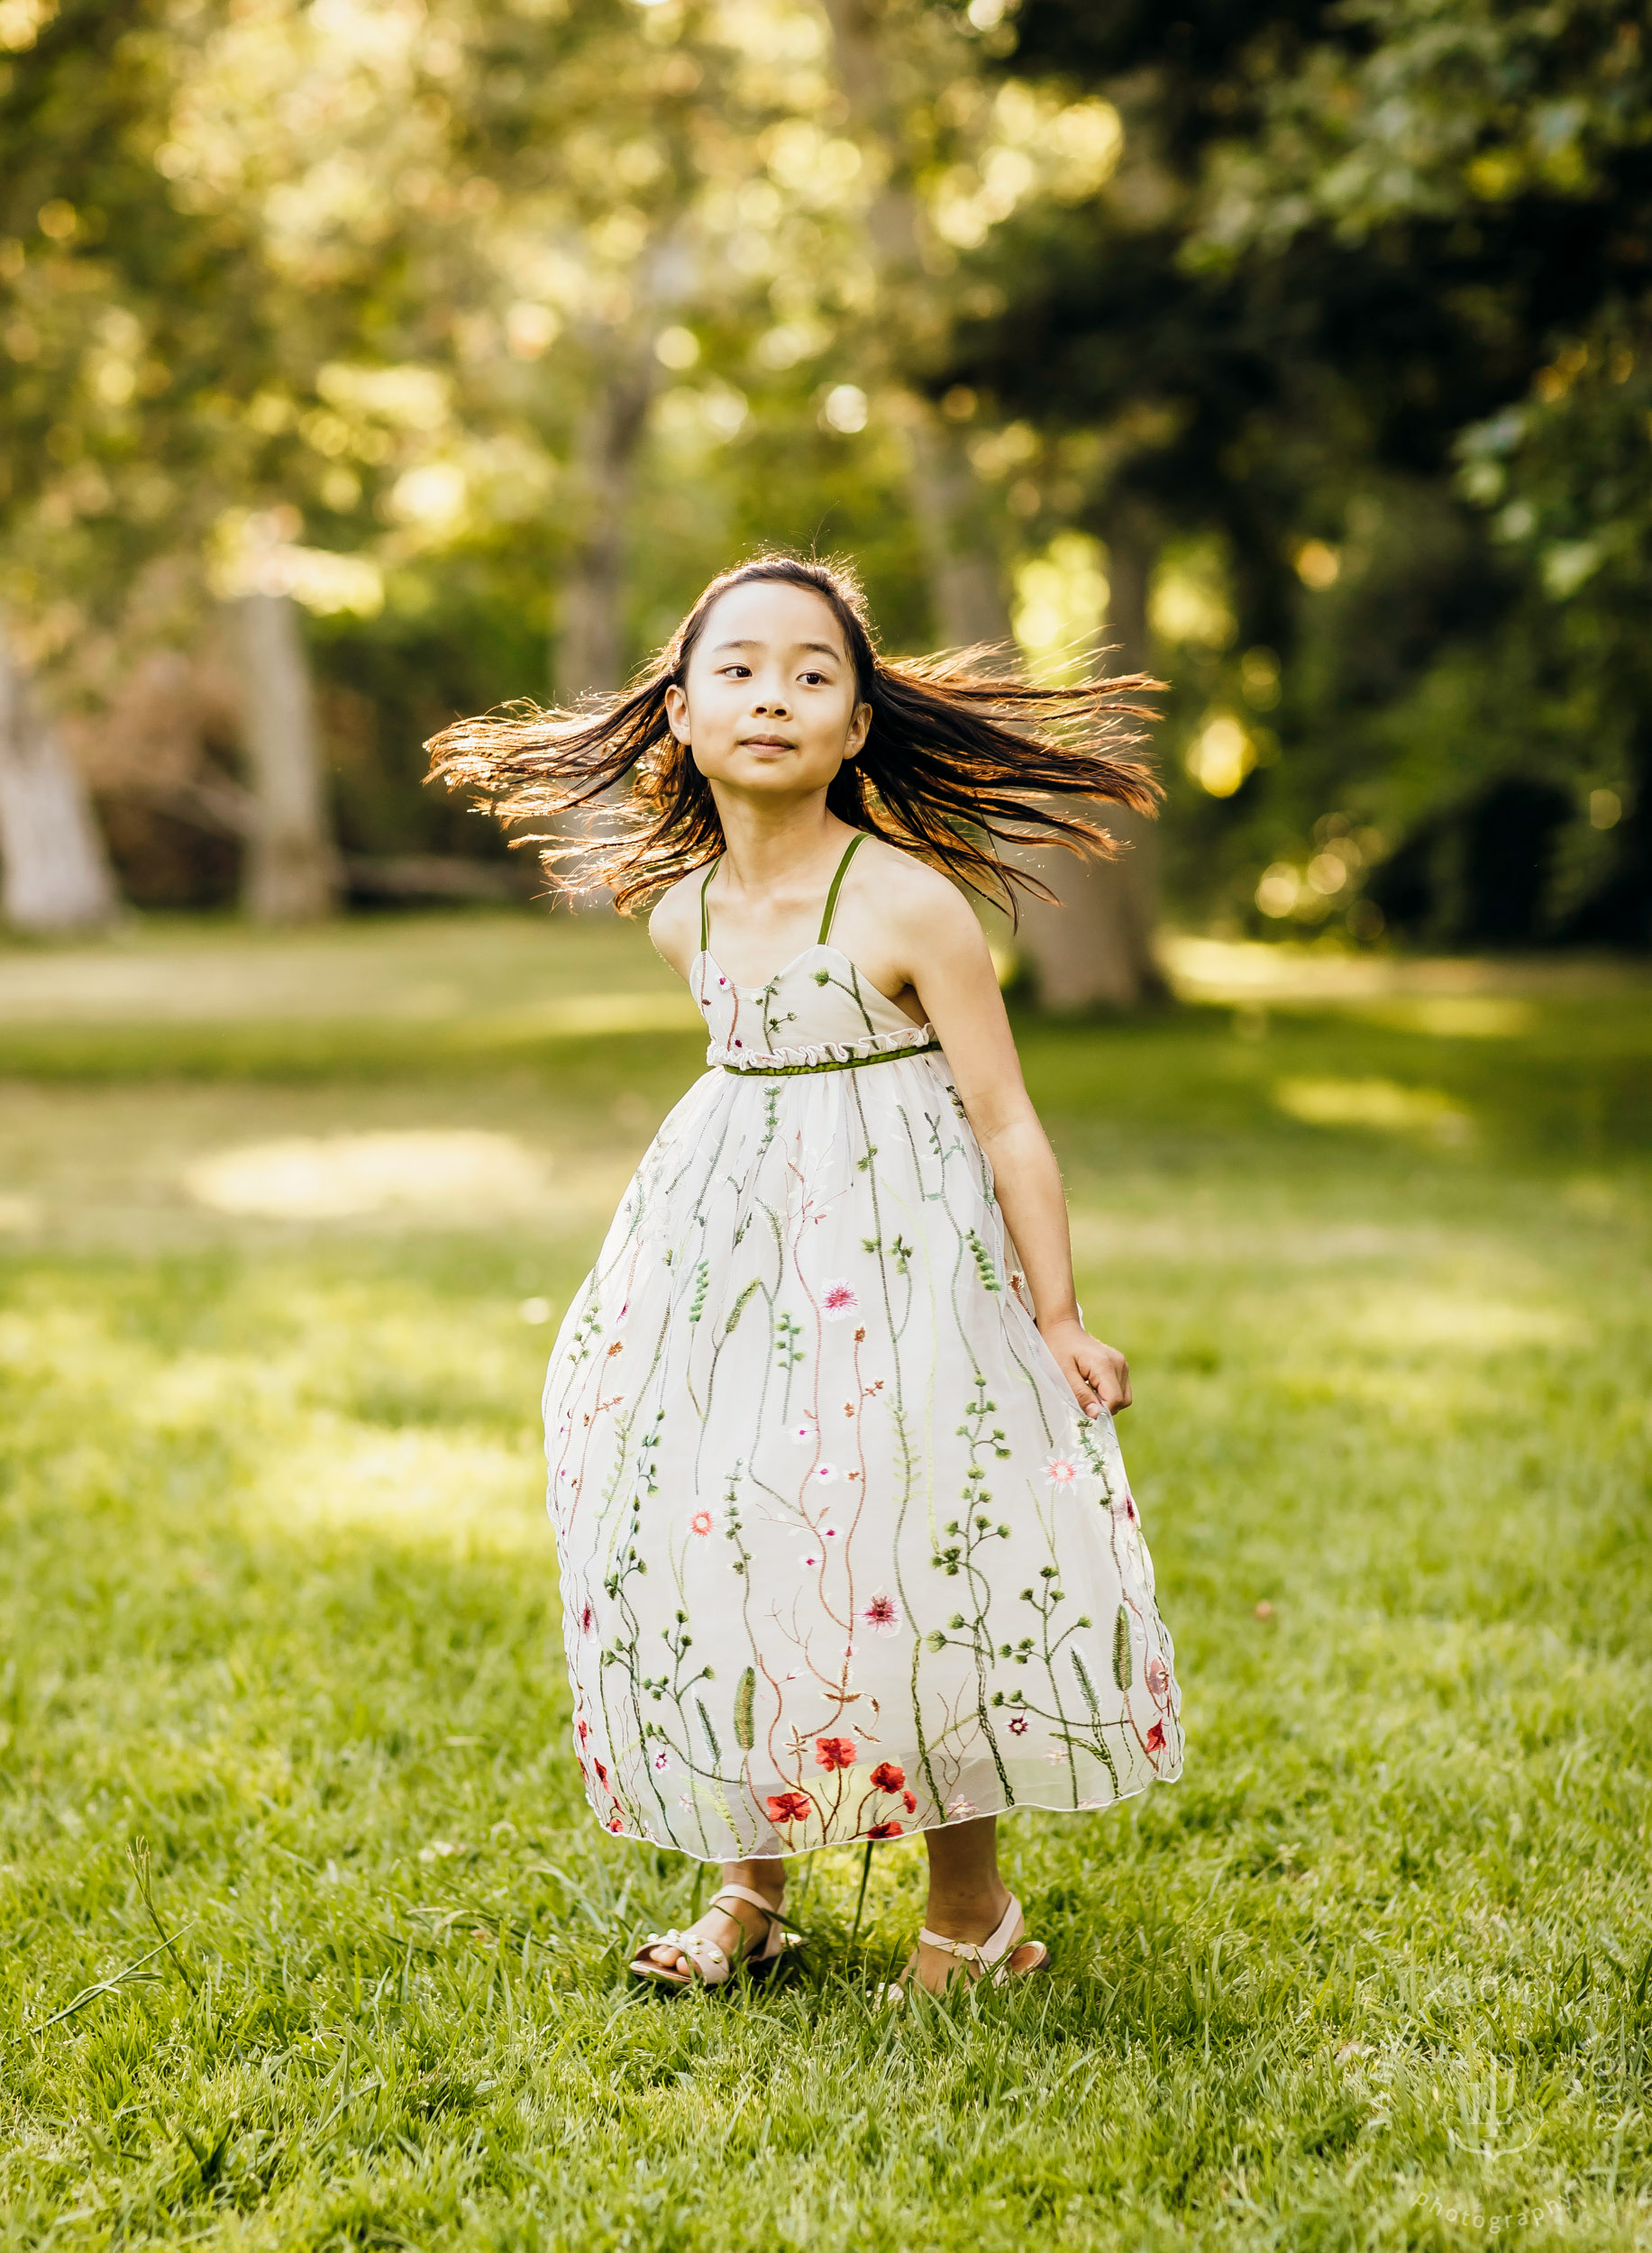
[424,554,1163,917]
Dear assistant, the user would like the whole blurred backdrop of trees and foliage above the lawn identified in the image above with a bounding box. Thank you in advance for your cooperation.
[0,0,1652,987]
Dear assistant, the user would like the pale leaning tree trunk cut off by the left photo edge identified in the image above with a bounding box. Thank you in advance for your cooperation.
[0,635,120,933]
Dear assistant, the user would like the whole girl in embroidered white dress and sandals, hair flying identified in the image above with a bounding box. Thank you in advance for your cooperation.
[431,557,1181,1990]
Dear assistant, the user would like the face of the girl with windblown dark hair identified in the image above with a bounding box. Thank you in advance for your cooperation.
[665,579,872,798]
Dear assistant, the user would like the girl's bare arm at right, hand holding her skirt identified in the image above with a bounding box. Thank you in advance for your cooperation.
[883,863,1131,1415]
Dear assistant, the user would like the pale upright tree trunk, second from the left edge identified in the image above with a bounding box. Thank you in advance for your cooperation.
[230,595,342,924]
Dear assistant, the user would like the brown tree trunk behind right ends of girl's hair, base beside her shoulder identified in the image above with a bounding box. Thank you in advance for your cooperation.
[1018,507,1165,1009]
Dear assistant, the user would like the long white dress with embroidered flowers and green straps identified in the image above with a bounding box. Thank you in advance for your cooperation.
[545,841,1181,1861]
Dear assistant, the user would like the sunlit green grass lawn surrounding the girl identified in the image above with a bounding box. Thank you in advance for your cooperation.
[0,915,1652,2253]
